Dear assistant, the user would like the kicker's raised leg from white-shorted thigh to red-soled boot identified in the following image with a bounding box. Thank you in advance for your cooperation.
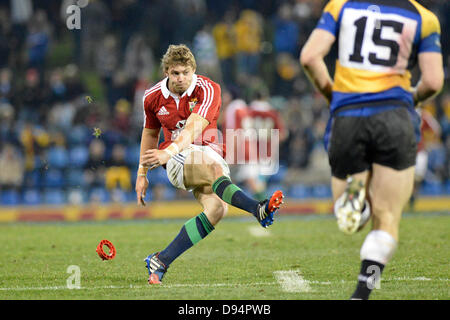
[184,150,283,227]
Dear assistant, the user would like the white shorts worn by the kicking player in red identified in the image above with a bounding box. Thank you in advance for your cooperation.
[166,144,230,191]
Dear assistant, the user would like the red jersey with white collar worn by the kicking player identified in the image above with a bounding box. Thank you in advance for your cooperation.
[143,74,225,157]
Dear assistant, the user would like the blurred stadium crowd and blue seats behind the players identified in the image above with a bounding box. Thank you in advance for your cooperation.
[0,0,450,222]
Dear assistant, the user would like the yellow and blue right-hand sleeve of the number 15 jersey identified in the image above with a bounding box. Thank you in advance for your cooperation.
[418,11,442,53]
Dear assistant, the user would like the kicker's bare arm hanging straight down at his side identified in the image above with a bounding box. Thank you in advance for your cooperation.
[135,128,160,206]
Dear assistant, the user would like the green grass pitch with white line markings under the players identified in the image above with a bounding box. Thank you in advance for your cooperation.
[0,213,450,300]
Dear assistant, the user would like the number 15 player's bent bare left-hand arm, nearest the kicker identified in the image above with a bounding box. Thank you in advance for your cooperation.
[300,29,335,102]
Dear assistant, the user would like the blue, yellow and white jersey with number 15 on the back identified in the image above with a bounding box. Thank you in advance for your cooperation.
[317,0,441,116]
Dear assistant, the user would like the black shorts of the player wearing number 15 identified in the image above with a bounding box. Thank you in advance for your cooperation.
[328,107,417,179]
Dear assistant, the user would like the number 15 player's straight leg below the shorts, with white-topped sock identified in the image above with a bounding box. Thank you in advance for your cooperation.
[352,164,414,299]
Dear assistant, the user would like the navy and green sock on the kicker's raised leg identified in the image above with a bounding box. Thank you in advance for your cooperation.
[212,176,259,216]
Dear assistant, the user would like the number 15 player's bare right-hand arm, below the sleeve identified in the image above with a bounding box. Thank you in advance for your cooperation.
[413,52,444,105]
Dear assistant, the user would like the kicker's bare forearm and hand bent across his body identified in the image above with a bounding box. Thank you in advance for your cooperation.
[141,113,209,169]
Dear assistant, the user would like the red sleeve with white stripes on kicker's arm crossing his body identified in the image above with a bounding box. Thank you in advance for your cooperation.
[192,79,222,123]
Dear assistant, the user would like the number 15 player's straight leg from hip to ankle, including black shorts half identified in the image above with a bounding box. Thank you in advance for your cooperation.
[352,108,417,299]
